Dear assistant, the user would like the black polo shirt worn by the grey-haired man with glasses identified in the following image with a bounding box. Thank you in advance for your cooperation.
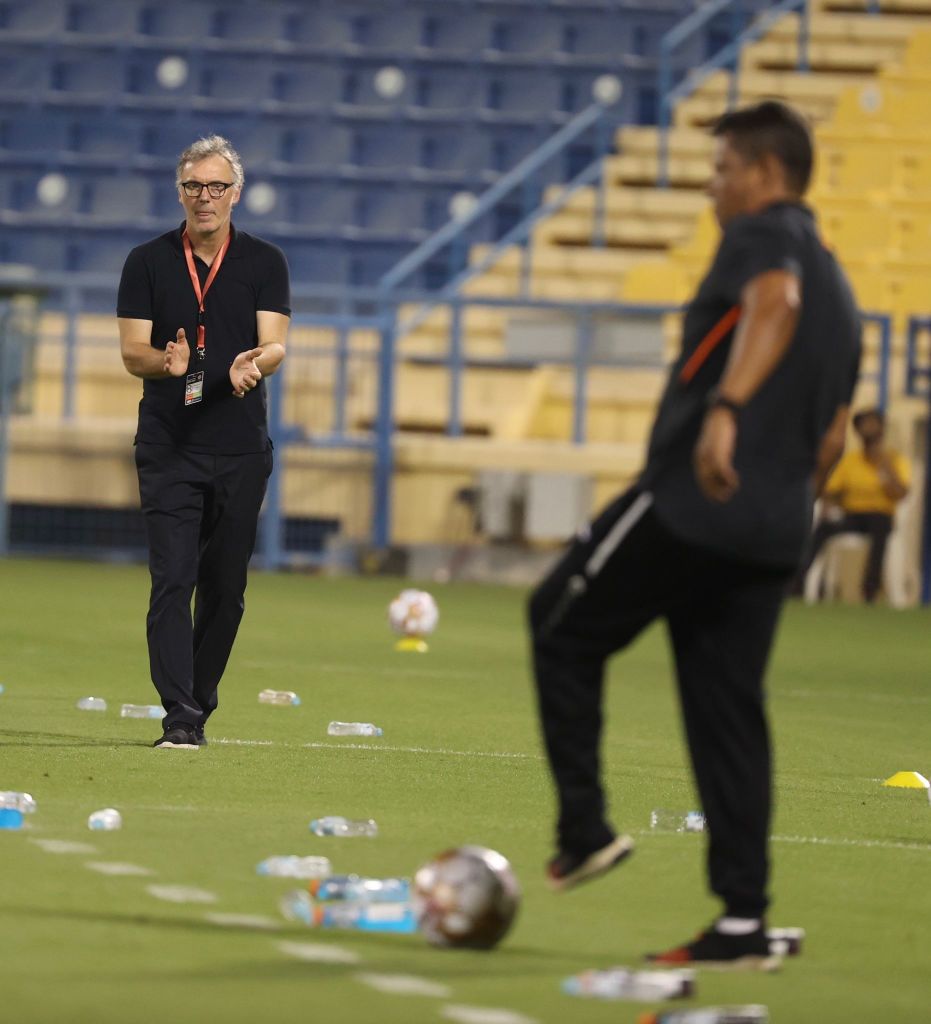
[117,224,291,455]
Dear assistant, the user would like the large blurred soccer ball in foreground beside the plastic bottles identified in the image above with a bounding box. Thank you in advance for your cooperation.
[412,846,520,949]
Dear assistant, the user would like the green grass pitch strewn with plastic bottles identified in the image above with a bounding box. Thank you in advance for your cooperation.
[0,560,931,1024]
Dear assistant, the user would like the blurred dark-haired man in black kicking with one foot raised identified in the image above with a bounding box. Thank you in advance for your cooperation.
[530,102,860,967]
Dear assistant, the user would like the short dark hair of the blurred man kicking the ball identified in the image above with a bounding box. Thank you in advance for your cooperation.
[711,99,814,196]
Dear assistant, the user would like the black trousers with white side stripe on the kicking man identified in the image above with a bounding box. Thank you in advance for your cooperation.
[530,492,792,916]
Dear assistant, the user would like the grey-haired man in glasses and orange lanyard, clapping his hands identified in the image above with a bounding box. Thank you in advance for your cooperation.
[117,135,291,750]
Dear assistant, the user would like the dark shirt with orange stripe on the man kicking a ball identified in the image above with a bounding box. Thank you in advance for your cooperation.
[641,203,860,567]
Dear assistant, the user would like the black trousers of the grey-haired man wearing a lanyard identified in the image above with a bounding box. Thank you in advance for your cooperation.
[135,444,271,729]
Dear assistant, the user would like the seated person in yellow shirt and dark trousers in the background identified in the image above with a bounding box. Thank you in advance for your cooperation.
[797,409,912,603]
